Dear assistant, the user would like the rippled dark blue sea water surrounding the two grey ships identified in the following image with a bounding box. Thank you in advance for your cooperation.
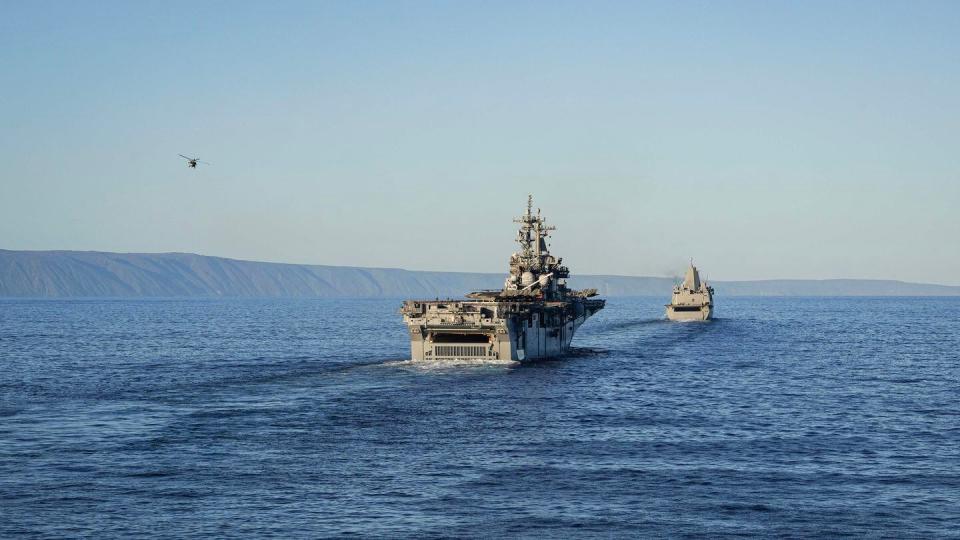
[0,298,960,538]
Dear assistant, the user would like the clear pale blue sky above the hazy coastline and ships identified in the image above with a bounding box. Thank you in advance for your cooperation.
[0,0,960,285]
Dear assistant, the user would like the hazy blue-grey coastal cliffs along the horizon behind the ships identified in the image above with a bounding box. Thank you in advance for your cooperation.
[0,249,960,298]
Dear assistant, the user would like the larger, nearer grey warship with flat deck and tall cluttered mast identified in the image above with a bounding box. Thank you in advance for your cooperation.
[400,196,606,360]
